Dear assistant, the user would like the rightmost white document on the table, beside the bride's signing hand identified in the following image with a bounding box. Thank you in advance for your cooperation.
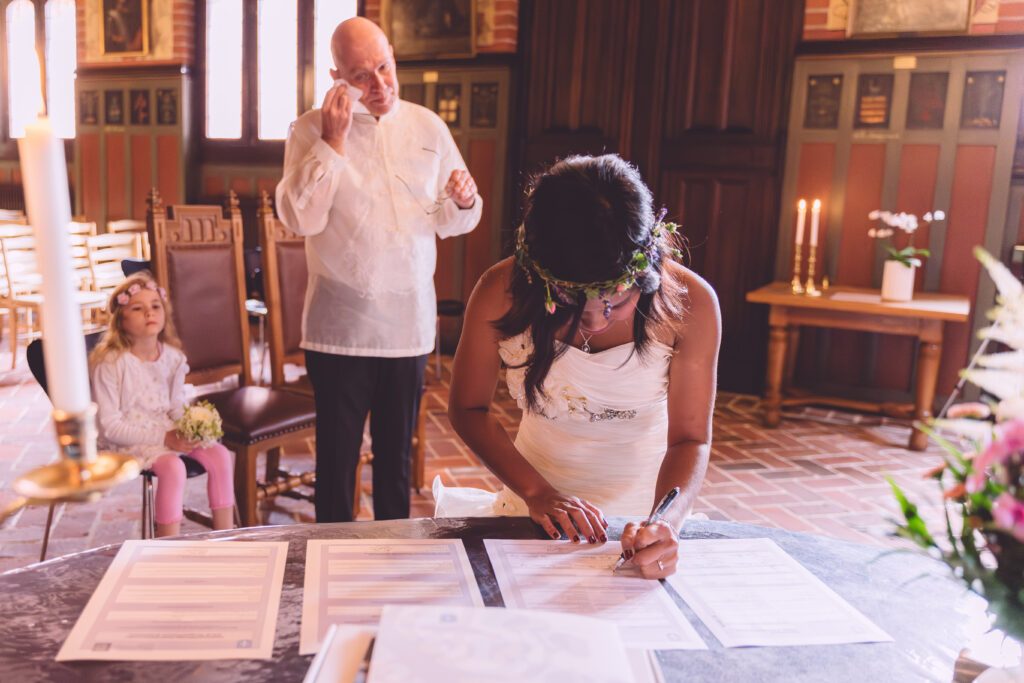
[668,539,892,647]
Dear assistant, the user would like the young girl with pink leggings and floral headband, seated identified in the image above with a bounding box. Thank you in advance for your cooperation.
[90,272,234,537]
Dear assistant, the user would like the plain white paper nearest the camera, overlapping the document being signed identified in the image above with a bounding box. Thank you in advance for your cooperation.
[367,605,634,683]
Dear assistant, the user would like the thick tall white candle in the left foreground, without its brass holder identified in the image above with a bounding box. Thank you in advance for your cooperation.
[17,117,91,413]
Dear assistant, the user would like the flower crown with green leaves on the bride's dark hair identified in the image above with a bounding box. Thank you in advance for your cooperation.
[515,209,683,318]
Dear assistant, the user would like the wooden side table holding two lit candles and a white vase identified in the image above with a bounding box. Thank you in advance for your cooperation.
[746,283,971,451]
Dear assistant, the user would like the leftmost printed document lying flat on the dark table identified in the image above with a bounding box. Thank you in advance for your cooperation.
[56,541,288,661]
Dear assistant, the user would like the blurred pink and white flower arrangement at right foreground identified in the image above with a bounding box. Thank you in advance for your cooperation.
[889,247,1024,637]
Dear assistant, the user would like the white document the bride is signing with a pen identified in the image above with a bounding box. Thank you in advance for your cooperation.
[483,539,708,650]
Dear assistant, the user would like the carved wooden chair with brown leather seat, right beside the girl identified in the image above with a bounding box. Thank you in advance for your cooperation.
[146,190,316,526]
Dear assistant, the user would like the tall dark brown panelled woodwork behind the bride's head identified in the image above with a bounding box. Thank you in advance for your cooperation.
[513,0,803,391]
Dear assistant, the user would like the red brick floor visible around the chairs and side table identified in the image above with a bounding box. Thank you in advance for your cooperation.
[0,344,940,570]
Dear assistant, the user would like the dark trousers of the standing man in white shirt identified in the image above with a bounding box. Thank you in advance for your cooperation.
[306,351,427,522]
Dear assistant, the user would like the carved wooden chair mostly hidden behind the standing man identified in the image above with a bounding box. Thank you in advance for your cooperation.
[256,190,426,505]
